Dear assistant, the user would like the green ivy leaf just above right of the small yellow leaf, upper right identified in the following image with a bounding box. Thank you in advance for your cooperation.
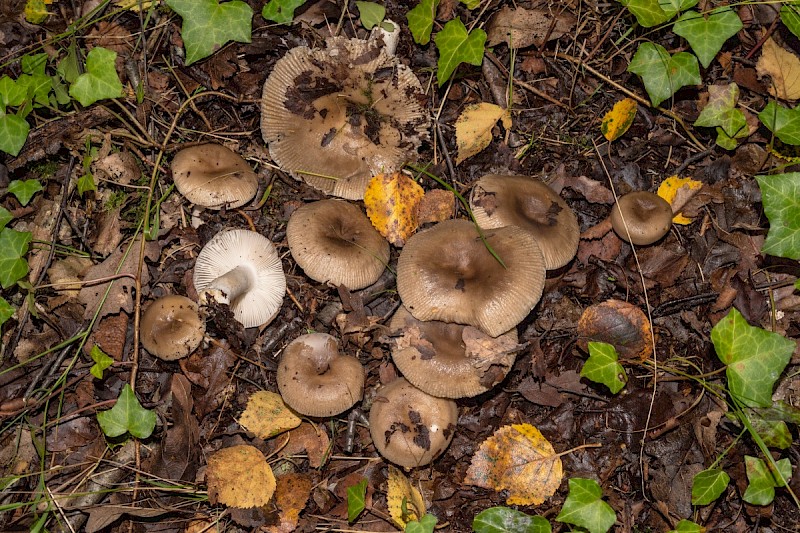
[628,42,702,107]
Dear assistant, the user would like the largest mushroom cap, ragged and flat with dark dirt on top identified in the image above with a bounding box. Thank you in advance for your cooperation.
[261,37,430,200]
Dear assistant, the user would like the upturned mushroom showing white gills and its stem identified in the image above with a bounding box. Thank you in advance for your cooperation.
[194,229,286,328]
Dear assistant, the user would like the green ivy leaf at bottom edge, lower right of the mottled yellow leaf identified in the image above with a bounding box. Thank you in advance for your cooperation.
[556,478,617,533]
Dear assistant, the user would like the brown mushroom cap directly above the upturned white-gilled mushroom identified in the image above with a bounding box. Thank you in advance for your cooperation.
[172,143,258,209]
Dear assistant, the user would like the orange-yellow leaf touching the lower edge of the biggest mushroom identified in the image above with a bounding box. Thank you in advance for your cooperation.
[364,172,425,247]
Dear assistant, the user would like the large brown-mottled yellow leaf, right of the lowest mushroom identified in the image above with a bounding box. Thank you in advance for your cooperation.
[464,424,563,505]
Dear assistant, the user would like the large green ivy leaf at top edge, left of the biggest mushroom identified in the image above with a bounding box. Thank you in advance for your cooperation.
[167,0,253,66]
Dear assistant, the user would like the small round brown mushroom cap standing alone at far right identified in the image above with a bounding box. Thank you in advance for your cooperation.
[611,191,672,246]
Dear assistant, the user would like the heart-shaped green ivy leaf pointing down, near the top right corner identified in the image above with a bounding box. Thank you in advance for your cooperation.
[672,7,742,68]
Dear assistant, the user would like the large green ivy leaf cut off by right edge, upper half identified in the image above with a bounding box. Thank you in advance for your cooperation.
[756,172,800,260]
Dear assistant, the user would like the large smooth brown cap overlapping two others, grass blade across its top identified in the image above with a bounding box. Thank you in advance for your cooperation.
[397,219,545,337]
